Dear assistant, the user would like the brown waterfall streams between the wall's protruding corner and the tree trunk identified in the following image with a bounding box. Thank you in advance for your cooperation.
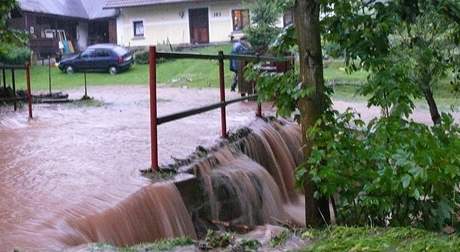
[192,121,308,226]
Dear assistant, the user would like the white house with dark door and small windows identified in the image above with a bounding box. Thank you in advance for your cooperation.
[105,0,250,47]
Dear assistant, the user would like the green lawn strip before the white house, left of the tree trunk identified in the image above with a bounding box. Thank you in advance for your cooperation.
[3,44,233,91]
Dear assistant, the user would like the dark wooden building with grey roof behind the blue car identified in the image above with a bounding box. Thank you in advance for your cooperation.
[9,0,117,58]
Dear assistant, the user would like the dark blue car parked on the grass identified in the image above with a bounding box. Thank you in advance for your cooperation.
[59,44,134,74]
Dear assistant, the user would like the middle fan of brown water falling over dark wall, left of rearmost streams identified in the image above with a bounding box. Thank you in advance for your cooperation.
[199,152,287,226]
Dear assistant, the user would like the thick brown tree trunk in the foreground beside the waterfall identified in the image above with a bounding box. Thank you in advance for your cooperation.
[295,0,330,227]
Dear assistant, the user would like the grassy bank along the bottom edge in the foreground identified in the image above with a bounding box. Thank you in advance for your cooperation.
[85,226,460,252]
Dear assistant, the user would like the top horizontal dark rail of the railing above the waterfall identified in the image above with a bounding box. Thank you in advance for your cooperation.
[157,52,294,62]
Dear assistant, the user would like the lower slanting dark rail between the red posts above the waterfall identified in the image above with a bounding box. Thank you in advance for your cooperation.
[157,95,257,125]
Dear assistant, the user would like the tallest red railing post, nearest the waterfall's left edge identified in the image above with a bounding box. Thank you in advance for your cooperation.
[149,46,159,171]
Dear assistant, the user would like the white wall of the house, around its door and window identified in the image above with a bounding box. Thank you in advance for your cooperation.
[117,1,242,46]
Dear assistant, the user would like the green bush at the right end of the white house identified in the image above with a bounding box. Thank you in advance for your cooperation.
[244,0,285,54]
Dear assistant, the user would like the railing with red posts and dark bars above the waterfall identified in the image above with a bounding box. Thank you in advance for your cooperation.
[149,46,293,171]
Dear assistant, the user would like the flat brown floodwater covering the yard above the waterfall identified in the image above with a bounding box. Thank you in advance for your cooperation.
[0,86,270,251]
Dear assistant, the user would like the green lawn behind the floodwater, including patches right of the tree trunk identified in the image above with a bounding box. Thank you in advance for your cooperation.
[2,44,460,110]
